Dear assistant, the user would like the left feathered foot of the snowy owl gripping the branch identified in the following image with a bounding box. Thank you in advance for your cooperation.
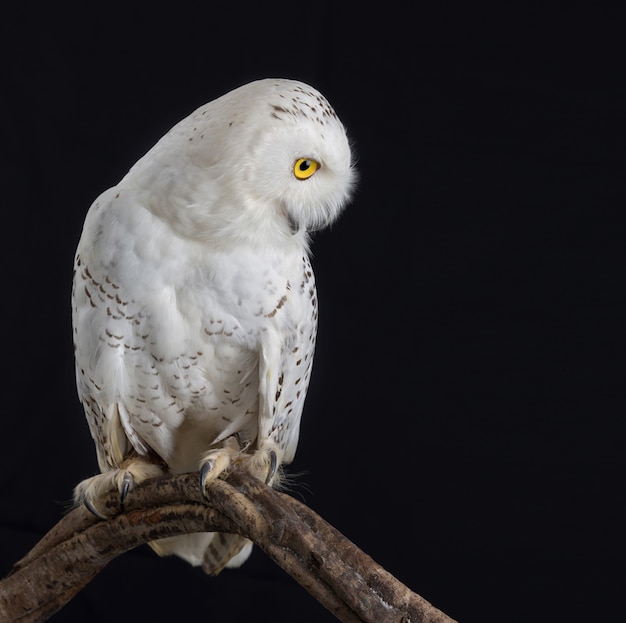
[74,457,163,519]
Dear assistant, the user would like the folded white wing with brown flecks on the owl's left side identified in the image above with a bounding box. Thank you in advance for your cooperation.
[72,188,181,471]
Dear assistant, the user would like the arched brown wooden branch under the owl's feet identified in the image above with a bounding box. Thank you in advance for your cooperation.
[0,470,453,623]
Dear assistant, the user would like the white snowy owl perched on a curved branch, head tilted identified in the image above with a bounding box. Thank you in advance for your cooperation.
[72,79,356,574]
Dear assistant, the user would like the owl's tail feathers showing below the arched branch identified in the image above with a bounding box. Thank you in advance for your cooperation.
[148,532,252,575]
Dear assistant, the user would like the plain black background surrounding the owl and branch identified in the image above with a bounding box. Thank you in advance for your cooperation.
[0,2,626,623]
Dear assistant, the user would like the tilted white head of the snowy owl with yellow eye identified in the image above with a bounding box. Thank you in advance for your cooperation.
[129,79,355,249]
